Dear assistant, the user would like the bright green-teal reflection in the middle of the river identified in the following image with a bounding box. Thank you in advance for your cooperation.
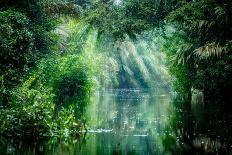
[84,89,171,154]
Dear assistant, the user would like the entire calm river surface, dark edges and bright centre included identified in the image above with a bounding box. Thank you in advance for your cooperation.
[0,89,232,155]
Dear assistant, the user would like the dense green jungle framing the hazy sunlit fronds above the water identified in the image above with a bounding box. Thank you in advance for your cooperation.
[0,0,232,145]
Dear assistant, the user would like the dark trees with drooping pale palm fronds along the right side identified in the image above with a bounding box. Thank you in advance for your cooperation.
[164,0,232,104]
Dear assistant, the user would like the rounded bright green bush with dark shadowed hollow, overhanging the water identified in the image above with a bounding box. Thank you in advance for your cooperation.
[36,55,93,105]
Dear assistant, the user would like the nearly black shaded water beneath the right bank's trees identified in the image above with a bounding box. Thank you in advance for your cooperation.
[166,97,232,154]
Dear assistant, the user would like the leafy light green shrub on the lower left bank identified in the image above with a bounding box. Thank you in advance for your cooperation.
[0,87,54,137]
